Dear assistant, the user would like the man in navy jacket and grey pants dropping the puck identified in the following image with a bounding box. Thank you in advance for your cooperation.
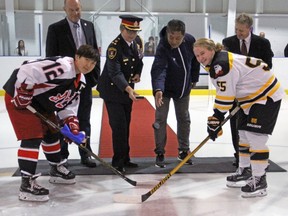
[151,20,200,168]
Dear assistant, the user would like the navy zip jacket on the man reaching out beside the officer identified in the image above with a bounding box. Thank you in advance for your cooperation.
[151,27,200,98]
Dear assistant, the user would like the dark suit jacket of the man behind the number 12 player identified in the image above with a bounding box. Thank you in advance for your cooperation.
[46,18,100,87]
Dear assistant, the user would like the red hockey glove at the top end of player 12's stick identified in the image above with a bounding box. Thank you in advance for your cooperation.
[12,85,34,109]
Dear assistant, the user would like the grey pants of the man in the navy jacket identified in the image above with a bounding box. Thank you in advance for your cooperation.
[153,95,191,154]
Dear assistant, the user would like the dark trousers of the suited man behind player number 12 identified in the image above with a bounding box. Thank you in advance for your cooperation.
[60,86,92,159]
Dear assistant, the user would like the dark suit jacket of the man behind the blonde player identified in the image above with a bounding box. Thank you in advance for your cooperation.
[222,34,274,69]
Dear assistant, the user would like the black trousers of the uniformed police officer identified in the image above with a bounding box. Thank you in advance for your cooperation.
[105,101,132,167]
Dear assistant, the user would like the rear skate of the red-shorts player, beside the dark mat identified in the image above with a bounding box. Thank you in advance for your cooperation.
[49,161,76,184]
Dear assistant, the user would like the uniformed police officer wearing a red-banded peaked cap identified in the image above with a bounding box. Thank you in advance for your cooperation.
[97,15,143,172]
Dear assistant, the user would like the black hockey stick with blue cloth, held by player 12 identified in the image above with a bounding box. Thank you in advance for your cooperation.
[26,105,137,186]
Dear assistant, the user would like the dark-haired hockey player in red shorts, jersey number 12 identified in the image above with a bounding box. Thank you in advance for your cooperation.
[3,45,99,201]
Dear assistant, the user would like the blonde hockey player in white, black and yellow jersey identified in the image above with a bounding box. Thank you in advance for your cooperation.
[193,38,285,198]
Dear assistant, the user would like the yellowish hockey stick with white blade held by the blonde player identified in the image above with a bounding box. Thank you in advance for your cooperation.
[114,106,240,203]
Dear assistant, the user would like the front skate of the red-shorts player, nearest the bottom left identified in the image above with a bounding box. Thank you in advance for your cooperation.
[19,174,49,202]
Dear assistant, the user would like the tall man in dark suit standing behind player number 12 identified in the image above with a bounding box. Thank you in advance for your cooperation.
[46,0,100,167]
